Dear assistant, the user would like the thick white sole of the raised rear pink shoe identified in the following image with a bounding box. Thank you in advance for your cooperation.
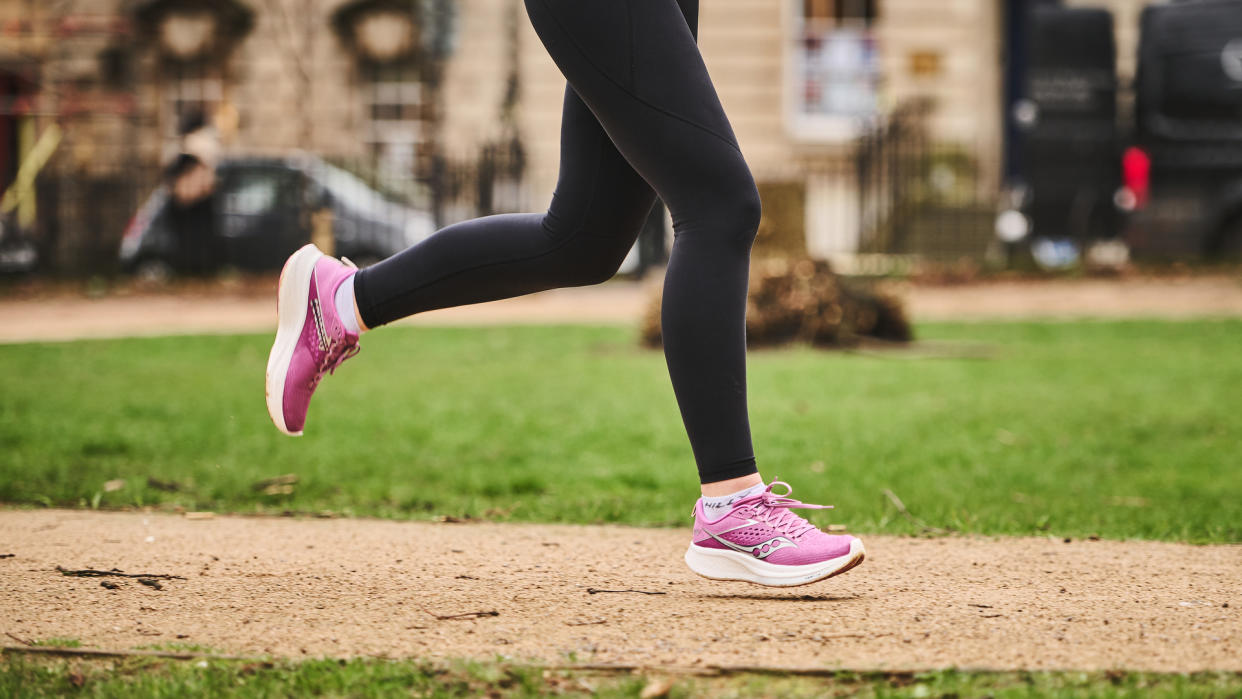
[265,243,323,437]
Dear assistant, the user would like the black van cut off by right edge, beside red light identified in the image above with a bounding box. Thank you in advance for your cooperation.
[1118,0,1242,258]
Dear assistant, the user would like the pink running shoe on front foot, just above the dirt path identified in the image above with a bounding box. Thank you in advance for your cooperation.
[686,480,866,587]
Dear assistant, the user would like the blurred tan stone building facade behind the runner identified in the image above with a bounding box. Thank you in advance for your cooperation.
[0,0,1162,270]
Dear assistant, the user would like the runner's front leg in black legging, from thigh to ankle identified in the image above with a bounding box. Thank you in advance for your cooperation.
[525,0,759,483]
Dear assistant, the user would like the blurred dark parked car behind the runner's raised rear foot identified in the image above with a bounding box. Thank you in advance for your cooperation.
[120,156,435,274]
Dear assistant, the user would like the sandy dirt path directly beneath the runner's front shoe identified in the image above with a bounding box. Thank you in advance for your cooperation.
[0,510,1242,670]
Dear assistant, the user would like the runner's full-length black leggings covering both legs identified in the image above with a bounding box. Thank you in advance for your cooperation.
[355,0,759,483]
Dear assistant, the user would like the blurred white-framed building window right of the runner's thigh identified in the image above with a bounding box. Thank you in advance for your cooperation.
[786,0,881,140]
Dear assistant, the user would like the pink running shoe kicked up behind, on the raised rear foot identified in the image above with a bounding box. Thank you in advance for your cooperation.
[267,245,358,437]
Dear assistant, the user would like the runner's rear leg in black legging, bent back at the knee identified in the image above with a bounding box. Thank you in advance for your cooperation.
[354,87,656,328]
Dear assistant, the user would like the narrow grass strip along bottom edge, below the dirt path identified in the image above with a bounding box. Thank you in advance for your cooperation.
[7,654,1242,699]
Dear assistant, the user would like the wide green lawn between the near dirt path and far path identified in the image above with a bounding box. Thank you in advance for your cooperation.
[0,320,1242,541]
